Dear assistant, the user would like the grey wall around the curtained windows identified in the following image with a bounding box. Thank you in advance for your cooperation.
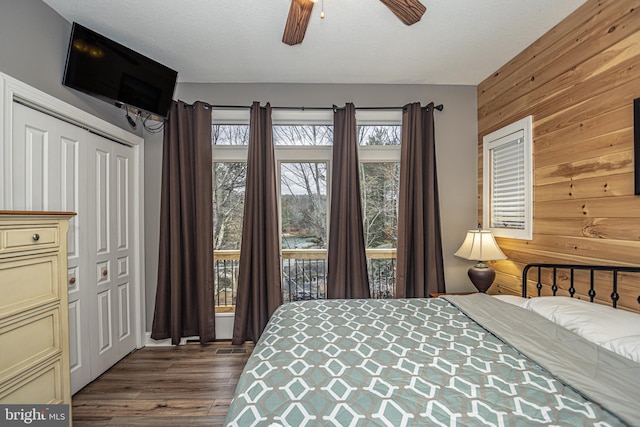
[145,83,478,330]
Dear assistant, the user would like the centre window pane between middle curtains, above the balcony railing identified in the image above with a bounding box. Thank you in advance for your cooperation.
[280,162,327,249]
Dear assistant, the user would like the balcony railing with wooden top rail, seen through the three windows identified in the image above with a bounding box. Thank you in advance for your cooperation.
[214,249,396,312]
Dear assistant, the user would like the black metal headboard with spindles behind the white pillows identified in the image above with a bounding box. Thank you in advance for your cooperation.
[522,264,640,308]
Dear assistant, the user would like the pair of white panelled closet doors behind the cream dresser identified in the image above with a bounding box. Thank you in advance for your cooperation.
[11,102,137,393]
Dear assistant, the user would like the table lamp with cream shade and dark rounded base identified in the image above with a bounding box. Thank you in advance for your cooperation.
[454,227,507,293]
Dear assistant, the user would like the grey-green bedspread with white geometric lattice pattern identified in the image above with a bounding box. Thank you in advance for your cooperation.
[226,298,624,427]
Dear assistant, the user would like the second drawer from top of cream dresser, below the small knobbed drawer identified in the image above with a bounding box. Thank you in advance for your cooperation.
[0,254,60,318]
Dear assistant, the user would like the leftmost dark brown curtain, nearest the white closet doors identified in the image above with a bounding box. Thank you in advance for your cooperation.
[151,101,215,345]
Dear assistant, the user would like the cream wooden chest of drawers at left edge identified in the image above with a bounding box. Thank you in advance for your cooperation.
[0,211,74,404]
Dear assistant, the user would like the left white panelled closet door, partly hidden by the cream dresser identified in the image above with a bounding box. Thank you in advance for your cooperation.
[10,102,91,393]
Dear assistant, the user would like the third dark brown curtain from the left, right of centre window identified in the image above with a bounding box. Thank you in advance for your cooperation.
[327,103,370,298]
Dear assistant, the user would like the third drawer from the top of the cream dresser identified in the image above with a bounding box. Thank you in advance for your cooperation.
[0,305,61,383]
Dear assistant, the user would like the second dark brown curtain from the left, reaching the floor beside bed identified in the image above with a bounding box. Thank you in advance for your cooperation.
[232,102,282,344]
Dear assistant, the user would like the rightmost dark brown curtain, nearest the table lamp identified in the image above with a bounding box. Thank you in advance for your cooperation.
[396,103,445,298]
